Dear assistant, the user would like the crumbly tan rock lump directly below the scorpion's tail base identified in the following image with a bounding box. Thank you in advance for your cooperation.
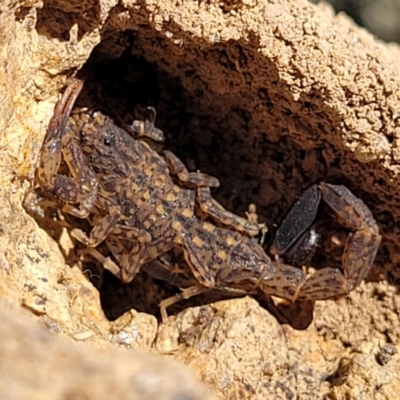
[156,298,343,399]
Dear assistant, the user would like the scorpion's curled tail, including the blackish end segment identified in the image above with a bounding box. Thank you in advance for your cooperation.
[270,183,381,301]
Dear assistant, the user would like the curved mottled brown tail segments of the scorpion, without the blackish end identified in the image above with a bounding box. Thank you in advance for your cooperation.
[297,183,381,300]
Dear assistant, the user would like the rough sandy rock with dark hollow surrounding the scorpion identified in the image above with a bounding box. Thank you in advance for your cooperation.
[0,0,400,399]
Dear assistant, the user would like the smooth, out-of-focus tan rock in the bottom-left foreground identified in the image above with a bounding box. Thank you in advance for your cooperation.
[0,302,214,400]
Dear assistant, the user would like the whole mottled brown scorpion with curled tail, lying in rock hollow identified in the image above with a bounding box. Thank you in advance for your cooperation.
[25,80,381,320]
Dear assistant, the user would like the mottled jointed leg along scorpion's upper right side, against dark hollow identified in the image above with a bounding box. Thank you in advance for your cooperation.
[164,150,259,236]
